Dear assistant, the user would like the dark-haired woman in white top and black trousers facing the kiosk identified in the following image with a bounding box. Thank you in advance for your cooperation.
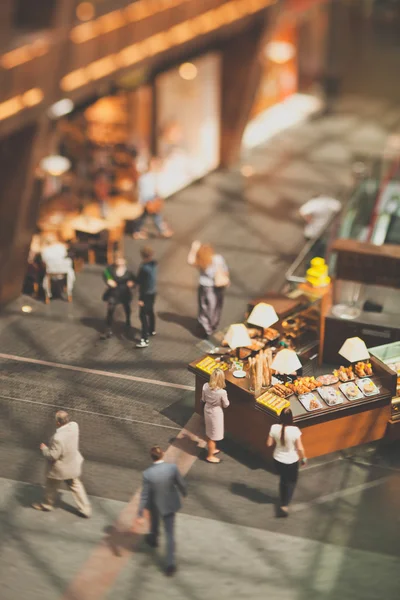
[267,408,306,517]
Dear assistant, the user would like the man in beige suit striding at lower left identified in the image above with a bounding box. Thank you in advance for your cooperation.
[32,410,92,518]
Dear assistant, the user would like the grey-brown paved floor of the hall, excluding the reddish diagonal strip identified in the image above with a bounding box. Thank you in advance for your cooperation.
[0,97,400,600]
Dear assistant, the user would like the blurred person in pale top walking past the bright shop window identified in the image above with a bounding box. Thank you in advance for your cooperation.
[133,157,173,240]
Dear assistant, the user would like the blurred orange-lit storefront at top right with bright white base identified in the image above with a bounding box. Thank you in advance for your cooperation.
[243,0,328,148]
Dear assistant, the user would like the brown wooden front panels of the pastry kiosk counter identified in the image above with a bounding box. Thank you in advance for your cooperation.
[188,357,396,460]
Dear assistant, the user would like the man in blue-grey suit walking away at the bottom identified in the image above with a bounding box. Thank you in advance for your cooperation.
[138,446,187,576]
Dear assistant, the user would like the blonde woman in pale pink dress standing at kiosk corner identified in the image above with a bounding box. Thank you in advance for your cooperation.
[201,369,229,464]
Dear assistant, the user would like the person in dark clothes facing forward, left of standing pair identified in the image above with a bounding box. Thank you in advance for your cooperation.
[103,256,135,338]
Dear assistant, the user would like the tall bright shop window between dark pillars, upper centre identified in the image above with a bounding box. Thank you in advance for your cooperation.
[155,53,221,196]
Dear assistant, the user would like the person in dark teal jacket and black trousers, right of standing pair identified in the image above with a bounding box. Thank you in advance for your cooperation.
[136,246,157,348]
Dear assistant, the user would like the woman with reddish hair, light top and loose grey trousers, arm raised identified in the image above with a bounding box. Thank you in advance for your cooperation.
[188,240,229,337]
